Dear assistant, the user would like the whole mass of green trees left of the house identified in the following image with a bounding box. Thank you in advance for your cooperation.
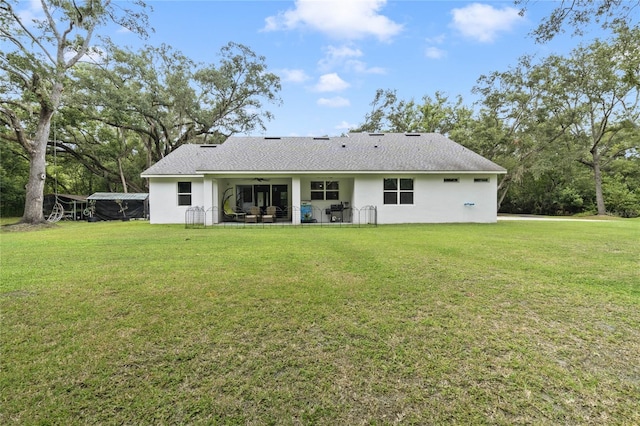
[0,0,280,223]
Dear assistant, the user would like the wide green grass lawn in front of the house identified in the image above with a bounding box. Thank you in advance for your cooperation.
[0,220,640,425]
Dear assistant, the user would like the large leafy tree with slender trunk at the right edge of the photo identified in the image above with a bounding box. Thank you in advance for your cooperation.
[476,26,640,214]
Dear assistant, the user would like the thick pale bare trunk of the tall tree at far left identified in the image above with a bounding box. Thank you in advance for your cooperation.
[22,107,53,224]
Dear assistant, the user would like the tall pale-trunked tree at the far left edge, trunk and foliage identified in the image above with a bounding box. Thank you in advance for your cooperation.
[0,0,149,223]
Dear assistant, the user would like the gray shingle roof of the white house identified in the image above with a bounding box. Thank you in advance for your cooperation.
[143,133,505,176]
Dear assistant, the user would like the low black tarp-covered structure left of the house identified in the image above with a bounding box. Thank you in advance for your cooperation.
[87,192,149,220]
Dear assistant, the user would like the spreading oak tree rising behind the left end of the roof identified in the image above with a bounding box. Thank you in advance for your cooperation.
[71,42,280,166]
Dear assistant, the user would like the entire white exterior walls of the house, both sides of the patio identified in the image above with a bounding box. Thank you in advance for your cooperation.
[149,174,498,224]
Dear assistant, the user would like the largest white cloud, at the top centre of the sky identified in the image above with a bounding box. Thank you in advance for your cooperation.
[263,0,402,41]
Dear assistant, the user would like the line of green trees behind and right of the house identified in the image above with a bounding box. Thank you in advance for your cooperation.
[355,26,640,217]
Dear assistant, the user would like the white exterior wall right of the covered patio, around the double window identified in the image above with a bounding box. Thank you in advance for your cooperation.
[353,175,497,224]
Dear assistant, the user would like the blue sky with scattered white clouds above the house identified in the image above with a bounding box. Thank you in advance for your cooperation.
[25,0,616,136]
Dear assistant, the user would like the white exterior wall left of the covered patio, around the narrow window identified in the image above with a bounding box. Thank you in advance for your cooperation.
[149,177,204,224]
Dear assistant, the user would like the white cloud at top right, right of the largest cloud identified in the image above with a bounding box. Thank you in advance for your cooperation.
[451,3,524,43]
